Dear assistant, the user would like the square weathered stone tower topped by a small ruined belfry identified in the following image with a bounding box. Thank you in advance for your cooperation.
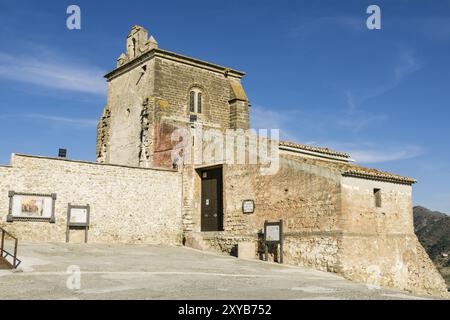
[97,26,249,167]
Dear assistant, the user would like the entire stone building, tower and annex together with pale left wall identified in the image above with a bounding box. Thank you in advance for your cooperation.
[0,26,446,294]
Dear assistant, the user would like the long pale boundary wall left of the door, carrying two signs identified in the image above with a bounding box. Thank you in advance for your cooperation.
[0,155,182,244]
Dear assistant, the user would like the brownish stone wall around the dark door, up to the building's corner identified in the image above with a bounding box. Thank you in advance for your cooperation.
[185,157,341,271]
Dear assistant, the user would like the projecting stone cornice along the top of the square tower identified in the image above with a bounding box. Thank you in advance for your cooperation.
[105,48,245,81]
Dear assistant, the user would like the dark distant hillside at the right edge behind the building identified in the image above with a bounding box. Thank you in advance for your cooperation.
[414,206,450,288]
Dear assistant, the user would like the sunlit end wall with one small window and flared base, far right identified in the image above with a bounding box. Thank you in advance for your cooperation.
[340,177,446,294]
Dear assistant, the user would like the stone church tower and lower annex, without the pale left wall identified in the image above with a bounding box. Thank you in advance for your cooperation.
[91,27,445,294]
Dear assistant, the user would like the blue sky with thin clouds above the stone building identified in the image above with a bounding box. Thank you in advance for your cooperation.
[0,0,450,212]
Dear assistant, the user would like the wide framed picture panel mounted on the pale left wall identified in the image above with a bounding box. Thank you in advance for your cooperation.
[6,191,56,223]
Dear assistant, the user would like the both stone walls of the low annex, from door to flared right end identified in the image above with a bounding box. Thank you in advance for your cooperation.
[184,155,446,294]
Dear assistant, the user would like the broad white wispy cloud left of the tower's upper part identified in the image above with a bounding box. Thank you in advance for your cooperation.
[0,49,106,95]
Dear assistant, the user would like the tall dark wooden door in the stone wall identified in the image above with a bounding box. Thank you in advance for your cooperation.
[200,168,223,231]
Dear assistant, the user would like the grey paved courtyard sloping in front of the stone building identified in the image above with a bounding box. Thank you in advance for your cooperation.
[0,244,440,300]
